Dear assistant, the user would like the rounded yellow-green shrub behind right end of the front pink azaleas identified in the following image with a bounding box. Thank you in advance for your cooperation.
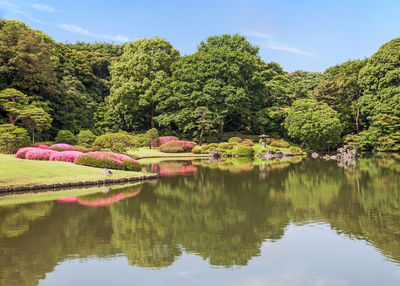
[93,132,139,152]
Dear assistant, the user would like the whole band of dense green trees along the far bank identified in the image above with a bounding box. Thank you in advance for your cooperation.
[0,19,400,150]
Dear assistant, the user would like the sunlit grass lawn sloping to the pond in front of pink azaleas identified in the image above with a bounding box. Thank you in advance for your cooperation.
[0,154,149,187]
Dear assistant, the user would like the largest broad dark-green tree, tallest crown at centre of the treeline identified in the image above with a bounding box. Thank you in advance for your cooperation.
[157,35,266,135]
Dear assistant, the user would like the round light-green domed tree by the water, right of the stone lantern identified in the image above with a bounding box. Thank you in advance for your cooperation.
[285,99,343,149]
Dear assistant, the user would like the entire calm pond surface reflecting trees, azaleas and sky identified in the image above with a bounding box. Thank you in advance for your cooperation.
[0,154,400,285]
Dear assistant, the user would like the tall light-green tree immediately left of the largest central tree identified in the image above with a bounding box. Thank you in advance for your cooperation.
[110,37,179,130]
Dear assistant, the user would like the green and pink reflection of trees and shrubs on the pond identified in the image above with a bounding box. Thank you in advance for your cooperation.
[0,155,400,285]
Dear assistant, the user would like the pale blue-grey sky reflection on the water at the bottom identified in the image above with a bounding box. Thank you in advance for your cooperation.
[39,224,400,286]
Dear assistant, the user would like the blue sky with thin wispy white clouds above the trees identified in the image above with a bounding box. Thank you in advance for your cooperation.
[0,0,400,72]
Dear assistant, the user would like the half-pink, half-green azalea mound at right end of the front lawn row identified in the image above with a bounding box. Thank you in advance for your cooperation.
[74,152,141,171]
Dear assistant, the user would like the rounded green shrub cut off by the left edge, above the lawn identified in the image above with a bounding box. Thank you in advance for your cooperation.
[0,124,30,154]
